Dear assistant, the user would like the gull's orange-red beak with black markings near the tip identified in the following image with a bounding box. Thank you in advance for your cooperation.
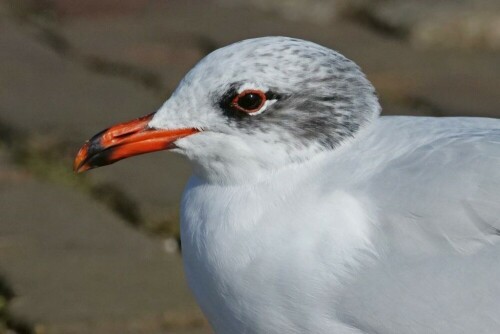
[73,114,199,173]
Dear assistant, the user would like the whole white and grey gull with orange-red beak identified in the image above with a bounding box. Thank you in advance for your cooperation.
[74,37,500,334]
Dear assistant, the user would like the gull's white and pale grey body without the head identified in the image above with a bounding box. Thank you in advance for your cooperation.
[182,117,500,334]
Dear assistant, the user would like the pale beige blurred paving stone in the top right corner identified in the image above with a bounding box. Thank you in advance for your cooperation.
[371,0,500,50]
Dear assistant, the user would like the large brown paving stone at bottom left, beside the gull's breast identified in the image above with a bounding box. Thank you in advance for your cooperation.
[0,171,207,333]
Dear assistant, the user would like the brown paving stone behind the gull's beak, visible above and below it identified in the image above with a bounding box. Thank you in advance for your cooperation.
[0,13,189,226]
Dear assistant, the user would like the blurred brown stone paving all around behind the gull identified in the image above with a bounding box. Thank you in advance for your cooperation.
[0,0,500,334]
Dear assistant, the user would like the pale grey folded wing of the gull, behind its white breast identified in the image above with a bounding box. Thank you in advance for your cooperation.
[340,119,500,333]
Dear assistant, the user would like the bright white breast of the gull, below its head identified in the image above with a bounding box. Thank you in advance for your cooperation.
[181,157,373,333]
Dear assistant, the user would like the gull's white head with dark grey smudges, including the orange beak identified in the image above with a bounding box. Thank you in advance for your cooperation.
[75,37,380,182]
